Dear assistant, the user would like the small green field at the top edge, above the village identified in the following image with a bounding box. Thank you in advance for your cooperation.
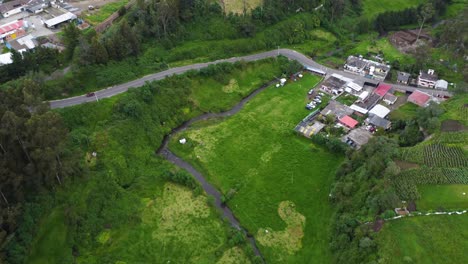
[362,0,424,18]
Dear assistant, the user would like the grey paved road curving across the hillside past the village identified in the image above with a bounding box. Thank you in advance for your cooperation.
[49,49,451,108]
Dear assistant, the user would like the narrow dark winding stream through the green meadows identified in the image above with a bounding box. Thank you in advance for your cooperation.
[157,80,276,261]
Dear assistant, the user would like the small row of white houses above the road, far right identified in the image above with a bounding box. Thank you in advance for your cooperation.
[397,69,448,90]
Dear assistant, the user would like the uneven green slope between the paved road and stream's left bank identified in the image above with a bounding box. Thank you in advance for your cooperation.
[22,59,285,263]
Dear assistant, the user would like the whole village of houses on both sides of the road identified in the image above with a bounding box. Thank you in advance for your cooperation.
[292,55,449,149]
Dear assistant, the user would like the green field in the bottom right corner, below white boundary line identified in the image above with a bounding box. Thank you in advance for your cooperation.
[378,214,468,263]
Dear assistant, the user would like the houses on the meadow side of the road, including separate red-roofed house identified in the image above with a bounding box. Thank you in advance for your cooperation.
[295,70,438,149]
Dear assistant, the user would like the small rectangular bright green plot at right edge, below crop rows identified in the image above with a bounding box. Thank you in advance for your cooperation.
[417,184,468,211]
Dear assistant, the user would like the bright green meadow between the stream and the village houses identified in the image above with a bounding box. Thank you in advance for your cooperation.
[170,75,342,263]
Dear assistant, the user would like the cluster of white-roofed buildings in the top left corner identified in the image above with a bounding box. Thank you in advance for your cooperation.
[0,0,77,65]
